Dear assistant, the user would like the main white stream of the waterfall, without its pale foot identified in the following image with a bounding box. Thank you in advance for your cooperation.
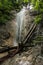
[16,7,26,42]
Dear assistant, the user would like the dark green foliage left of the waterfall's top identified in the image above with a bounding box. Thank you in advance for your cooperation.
[0,0,28,23]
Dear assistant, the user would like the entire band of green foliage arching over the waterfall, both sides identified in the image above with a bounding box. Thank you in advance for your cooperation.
[0,0,43,23]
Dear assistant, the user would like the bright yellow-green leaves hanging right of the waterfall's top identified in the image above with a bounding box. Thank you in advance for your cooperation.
[31,0,43,23]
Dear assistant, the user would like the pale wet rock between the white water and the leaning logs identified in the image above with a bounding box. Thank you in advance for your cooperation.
[21,10,33,39]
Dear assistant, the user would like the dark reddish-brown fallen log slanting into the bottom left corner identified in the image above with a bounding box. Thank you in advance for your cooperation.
[0,48,20,63]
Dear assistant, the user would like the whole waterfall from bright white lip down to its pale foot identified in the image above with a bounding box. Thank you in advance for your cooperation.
[14,5,32,46]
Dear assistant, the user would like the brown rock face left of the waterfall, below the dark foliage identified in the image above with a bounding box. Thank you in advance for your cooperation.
[0,20,15,46]
